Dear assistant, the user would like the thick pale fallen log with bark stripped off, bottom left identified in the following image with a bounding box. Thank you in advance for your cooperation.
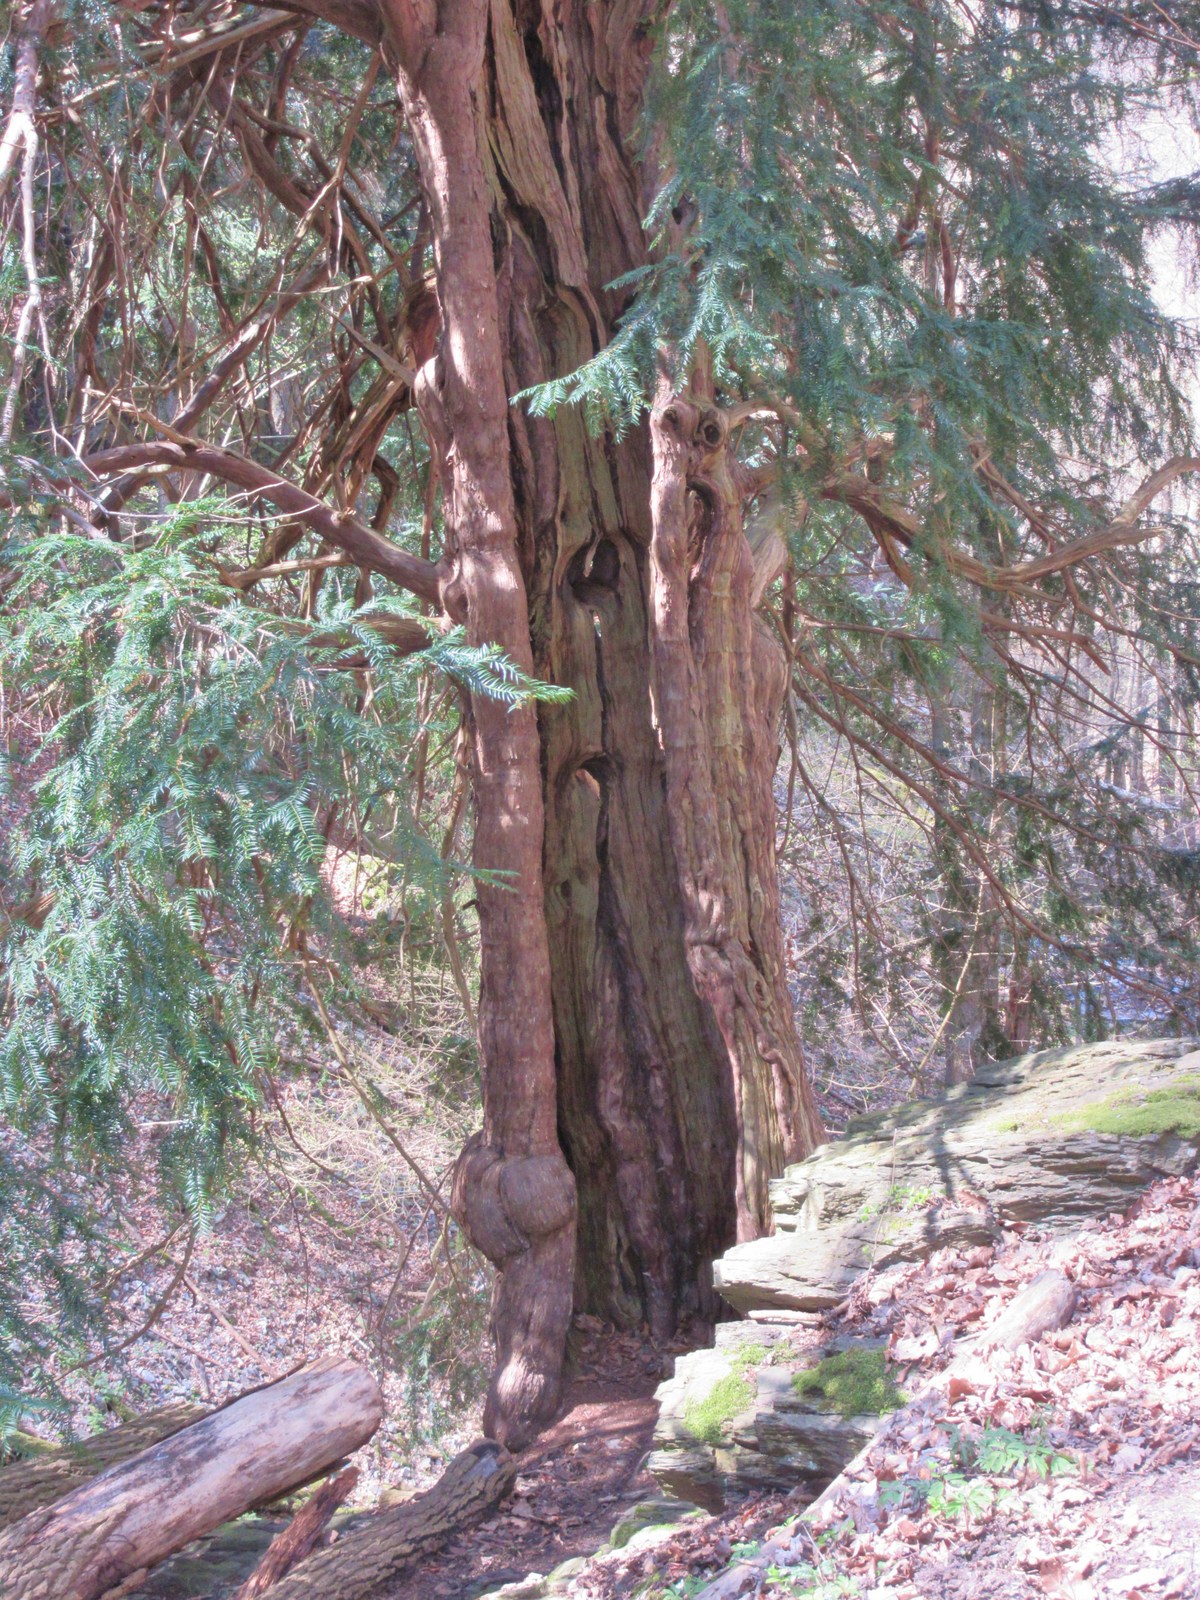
[0,1357,382,1600]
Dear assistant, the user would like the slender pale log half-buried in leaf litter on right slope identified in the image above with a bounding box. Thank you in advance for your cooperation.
[694,1272,1077,1600]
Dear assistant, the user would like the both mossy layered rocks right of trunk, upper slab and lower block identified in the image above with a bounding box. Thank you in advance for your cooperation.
[646,1038,1200,1510]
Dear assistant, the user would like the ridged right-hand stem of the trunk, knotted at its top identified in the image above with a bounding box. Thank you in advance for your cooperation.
[650,395,822,1240]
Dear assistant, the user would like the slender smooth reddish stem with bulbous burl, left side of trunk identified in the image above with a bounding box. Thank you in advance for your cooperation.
[384,0,574,1448]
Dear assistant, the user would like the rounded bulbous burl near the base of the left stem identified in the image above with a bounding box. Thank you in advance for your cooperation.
[451,1133,574,1267]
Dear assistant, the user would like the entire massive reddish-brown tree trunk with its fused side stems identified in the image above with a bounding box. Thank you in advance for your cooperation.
[386,0,821,1443]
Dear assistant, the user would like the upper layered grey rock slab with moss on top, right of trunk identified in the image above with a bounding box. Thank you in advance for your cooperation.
[714,1038,1200,1312]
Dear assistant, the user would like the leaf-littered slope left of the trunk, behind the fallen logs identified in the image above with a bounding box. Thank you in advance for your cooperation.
[43,1030,488,1506]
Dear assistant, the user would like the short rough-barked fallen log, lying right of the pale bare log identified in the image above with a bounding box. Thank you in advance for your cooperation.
[256,1440,517,1600]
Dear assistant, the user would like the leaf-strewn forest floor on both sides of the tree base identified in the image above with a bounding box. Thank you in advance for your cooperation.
[28,1059,1200,1600]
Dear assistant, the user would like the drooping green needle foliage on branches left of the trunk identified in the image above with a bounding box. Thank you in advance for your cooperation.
[0,502,554,1401]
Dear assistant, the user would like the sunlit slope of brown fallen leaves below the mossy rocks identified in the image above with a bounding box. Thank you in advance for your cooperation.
[499,1178,1200,1600]
